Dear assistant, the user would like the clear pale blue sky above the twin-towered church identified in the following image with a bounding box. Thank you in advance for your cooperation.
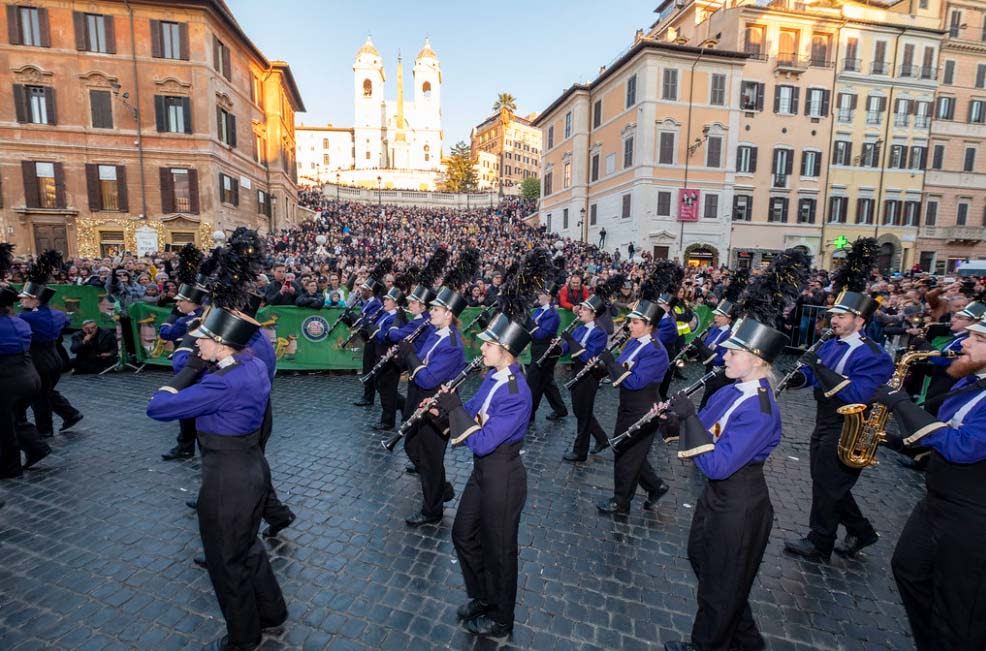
[233,0,657,152]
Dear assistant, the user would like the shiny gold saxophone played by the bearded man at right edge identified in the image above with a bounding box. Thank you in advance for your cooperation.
[836,350,954,469]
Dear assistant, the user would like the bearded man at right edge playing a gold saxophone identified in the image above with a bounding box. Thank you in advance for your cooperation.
[874,314,986,651]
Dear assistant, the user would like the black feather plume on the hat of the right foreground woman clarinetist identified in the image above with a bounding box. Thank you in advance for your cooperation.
[737,249,809,328]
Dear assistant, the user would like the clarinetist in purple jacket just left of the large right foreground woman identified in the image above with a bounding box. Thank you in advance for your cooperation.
[596,288,668,514]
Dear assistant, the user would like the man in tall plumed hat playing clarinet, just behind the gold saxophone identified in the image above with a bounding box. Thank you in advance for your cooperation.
[784,238,894,561]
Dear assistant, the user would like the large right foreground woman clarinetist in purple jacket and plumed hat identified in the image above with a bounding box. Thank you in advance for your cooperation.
[664,251,808,651]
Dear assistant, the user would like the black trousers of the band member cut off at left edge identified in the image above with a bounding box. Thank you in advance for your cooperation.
[0,353,51,477]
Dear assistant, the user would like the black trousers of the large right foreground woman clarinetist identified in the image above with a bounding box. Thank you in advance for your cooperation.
[688,463,774,651]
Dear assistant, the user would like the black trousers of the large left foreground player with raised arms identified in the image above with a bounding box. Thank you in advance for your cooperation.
[198,432,287,645]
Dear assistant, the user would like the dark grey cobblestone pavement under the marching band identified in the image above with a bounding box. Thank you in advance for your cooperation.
[0,362,924,651]
